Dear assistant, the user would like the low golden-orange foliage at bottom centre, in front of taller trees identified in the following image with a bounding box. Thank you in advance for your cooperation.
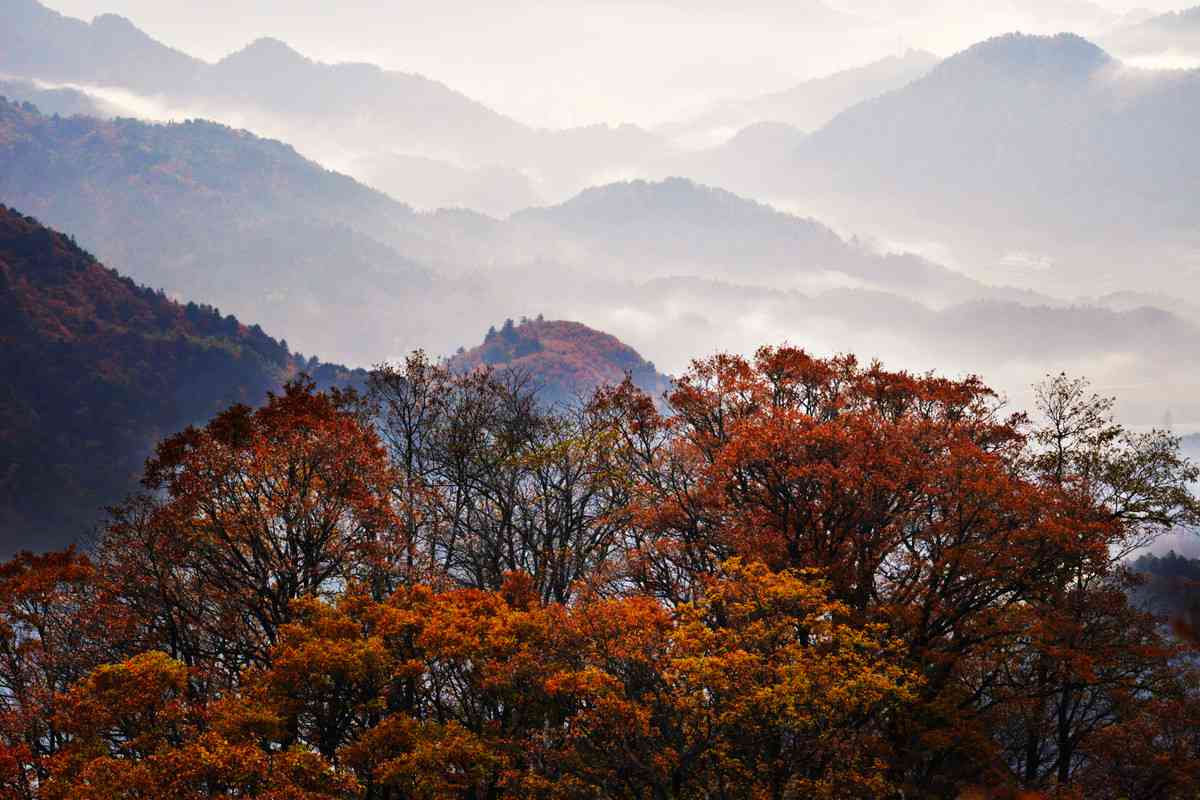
[223,563,918,800]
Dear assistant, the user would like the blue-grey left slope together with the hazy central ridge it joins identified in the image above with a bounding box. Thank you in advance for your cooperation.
[0,95,1032,363]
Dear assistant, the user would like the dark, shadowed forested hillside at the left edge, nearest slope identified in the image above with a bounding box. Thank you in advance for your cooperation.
[0,206,353,553]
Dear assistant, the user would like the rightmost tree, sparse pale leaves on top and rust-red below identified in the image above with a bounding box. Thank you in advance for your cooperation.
[992,375,1200,799]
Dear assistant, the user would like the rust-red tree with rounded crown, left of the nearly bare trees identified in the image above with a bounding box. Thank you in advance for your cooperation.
[96,381,404,681]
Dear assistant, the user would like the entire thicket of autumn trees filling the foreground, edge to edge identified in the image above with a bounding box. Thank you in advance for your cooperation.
[0,348,1200,800]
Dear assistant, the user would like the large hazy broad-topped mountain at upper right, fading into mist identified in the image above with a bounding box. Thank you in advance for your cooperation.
[696,35,1200,294]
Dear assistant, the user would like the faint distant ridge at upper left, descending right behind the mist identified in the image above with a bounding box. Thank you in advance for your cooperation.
[0,0,666,206]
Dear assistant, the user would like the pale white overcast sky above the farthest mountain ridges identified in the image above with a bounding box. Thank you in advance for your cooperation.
[39,0,1186,127]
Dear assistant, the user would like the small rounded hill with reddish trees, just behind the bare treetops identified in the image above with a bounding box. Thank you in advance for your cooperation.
[450,317,671,403]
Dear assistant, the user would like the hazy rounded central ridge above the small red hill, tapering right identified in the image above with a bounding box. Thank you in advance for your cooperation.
[510,178,997,303]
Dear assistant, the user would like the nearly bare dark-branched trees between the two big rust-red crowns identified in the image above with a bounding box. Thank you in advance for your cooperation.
[371,354,628,602]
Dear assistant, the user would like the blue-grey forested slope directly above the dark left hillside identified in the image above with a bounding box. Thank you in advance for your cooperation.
[0,95,430,360]
